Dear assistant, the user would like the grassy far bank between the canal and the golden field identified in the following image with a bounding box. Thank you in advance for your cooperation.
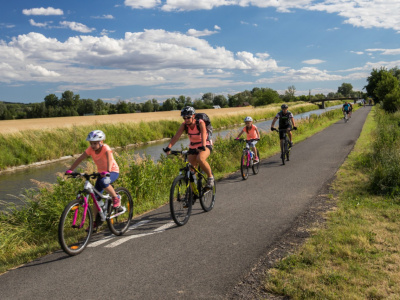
[0,101,340,170]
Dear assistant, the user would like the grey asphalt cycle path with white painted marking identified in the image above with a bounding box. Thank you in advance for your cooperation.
[0,107,370,299]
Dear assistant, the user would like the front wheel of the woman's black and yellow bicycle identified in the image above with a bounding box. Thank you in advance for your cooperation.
[169,175,193,226]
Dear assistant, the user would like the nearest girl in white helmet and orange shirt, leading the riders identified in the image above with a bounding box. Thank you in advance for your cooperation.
[65,130,122,230]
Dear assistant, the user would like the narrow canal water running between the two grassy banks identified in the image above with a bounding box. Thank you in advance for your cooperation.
[0,105,342,204]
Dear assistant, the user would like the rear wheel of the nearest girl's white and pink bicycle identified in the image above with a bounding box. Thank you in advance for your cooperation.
[107,187,133,235]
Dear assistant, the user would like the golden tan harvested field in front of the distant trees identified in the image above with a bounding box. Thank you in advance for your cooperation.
[0,106,262,134]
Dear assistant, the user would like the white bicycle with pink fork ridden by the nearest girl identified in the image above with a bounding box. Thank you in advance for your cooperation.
[58,172,133,256]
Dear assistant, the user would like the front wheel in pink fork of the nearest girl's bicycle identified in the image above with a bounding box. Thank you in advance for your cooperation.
[58,197,93,256]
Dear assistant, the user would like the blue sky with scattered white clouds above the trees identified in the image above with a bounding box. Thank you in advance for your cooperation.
[0,0,400,103]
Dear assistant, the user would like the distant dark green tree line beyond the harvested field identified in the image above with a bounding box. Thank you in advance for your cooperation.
[0,83,368,120]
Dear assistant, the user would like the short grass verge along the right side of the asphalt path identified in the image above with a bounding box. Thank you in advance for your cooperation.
[265,106,400,299]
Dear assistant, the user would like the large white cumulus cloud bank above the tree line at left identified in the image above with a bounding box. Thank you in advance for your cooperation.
[0,30,280,90]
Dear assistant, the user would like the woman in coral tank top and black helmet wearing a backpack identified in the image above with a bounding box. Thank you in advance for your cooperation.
[163,106,214,189]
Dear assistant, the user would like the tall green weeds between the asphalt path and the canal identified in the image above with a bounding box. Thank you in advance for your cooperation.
[0,105,342,273]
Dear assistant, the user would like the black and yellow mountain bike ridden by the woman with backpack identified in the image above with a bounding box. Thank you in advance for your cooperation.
[169,150,216,226]
